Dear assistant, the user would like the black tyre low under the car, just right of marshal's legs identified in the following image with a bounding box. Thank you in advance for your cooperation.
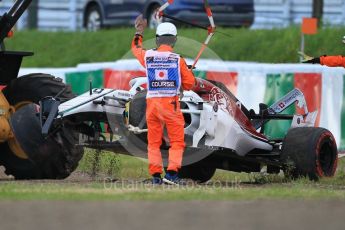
[178,158,216,183]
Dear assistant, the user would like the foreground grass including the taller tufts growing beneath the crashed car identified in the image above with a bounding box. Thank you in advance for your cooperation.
[0,150,345,201]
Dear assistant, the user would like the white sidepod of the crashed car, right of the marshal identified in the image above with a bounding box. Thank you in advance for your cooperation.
[181,91,272,156]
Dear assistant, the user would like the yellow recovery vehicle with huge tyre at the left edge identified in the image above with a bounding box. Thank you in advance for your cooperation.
[0,0,83,179]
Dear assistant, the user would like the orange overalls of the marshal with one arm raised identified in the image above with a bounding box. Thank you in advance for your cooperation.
[132,35,195,175]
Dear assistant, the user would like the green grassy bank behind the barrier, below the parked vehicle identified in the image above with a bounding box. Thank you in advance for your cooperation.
[6,27,345,67]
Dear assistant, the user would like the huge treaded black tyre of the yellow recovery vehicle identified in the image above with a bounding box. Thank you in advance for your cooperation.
[0,74,83,179]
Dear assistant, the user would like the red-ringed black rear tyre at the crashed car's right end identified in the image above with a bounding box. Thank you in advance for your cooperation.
[281,127,338,180]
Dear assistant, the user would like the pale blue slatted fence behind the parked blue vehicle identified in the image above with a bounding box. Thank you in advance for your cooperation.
[0,0,345,31]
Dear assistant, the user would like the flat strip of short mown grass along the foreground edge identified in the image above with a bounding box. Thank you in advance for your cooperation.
[0,182,345,200]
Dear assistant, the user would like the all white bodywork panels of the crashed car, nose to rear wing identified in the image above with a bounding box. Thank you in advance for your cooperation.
[57,78,317,156]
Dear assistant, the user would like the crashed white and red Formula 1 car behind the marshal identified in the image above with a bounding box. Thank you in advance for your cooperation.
[12,73,338,182]
